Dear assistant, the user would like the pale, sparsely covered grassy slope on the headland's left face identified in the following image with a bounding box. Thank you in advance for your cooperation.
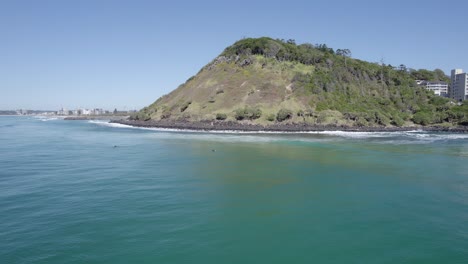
[140,55,314,123]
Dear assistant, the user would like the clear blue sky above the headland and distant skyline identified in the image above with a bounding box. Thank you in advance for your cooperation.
[0,0,468,110]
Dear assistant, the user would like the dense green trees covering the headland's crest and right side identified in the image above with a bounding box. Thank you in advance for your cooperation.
[222,37,468,126]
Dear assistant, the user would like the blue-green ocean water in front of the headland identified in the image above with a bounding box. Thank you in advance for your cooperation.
[0,117,468,263]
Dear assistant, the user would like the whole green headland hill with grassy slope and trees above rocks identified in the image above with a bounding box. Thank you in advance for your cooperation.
[131,37,468,127]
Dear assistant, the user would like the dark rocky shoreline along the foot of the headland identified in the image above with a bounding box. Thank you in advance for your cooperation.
[110,120,468,133]
